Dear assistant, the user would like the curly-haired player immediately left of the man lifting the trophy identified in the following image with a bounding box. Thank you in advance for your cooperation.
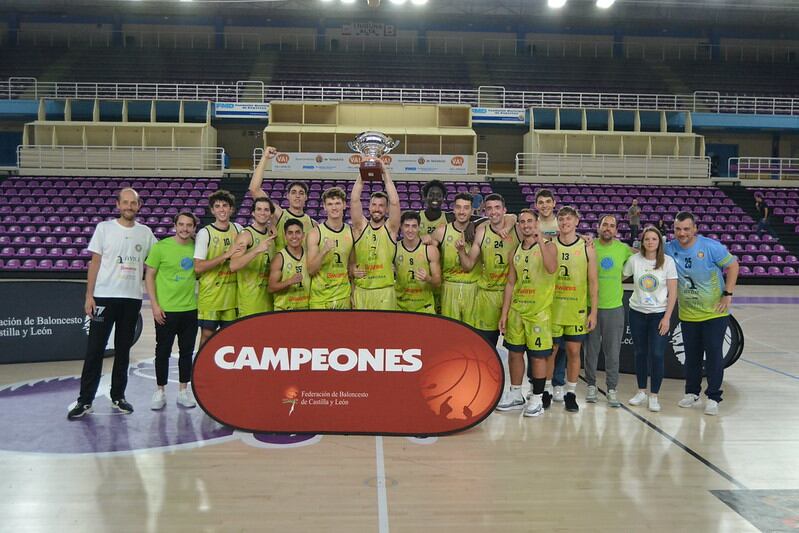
[308,187,353,309]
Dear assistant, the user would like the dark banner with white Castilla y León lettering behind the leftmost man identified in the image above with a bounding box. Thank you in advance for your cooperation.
[0,280,142,363]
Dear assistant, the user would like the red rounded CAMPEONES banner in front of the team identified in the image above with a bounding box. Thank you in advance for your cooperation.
[192,311,504,436]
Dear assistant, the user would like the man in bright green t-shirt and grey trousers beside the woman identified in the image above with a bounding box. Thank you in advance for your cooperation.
[585,215,633,407]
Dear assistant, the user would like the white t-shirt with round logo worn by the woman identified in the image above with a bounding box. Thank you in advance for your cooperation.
[624,254,677,314]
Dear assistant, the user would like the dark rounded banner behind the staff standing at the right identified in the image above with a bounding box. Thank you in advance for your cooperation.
[598,291,744,379]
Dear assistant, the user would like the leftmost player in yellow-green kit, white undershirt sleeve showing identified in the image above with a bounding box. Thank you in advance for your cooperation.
[194,189,241,346]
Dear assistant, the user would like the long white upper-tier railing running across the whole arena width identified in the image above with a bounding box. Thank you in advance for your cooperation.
[6,78,799,115]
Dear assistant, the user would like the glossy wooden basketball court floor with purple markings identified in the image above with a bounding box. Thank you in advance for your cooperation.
[0,287,799,533]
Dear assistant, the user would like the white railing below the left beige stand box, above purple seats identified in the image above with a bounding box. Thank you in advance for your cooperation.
[17,145,225,173]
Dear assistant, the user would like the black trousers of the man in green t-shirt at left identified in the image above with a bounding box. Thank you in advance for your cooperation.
[155,309,197,387]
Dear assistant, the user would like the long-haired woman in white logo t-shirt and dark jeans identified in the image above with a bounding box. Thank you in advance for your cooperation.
[624,226,677,412]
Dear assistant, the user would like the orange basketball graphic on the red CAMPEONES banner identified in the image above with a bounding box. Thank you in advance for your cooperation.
[421,354,502,420]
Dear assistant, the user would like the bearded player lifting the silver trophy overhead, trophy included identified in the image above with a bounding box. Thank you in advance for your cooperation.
[349,132,401,311]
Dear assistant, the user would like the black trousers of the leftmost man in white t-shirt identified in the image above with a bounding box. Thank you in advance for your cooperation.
[78,298,141,404]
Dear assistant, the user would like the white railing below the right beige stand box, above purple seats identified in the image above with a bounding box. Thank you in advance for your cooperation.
[516,153,710,179]
